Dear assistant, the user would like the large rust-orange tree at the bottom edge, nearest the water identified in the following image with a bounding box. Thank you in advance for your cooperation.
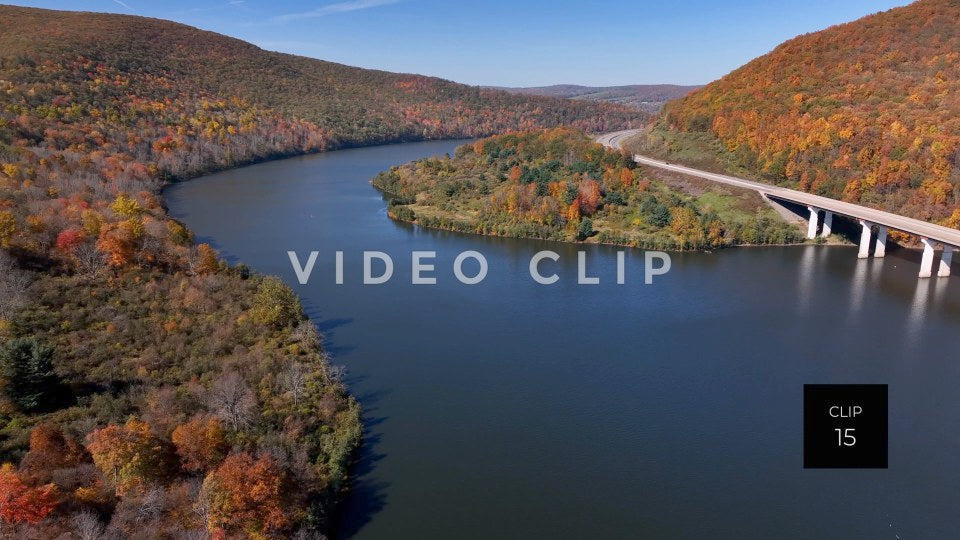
[200,453,303,537]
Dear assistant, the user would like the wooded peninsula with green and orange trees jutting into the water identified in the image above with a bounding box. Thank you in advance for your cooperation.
[373,128,801,250]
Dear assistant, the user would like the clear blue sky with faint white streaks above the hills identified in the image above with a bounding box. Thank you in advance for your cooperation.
[7,0,909,86]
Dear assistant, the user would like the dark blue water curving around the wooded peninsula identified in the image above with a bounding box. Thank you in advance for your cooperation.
[165,141,960,539]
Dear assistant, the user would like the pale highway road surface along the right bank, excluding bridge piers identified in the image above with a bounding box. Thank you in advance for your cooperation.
[596,129,960,248]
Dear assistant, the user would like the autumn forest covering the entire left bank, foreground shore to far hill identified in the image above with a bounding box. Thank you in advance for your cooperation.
[0,6,640,538]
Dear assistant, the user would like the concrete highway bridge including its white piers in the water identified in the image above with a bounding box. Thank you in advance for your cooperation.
[596,129,960,278]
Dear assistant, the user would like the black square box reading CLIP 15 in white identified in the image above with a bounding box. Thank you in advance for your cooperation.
[803,384,887,469]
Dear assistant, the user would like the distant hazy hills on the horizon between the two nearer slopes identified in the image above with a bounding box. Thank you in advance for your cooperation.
[490,84,701,113]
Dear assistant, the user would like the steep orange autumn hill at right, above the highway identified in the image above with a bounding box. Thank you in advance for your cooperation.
[663,0,960,227]
